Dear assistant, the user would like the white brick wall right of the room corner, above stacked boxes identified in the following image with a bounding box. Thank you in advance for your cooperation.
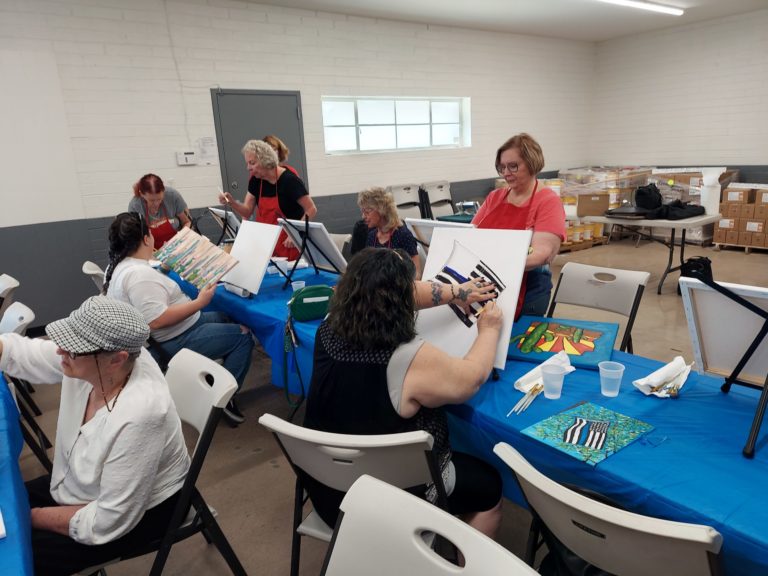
[589,10,768,166]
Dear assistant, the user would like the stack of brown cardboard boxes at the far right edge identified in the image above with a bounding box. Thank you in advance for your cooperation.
[715,183,768,248]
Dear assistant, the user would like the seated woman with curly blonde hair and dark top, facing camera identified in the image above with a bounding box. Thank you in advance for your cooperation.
[357,187,421,278]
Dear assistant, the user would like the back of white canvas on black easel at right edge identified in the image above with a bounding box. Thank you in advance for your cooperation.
[680,277,768,386]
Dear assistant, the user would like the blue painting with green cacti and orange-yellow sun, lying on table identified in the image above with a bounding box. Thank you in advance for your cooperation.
[507,316,619,370]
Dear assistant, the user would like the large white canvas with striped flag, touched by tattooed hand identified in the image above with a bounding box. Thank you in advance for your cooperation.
[416,227,532,370]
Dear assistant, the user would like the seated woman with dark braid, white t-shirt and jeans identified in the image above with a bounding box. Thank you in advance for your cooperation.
[104,212,253,425]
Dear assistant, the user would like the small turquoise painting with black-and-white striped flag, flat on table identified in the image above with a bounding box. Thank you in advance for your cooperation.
[522,402,653,466]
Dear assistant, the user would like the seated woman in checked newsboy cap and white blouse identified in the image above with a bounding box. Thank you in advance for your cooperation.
[0,296,189,576]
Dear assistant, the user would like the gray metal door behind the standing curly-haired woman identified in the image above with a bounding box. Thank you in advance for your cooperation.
[211,88,309,200]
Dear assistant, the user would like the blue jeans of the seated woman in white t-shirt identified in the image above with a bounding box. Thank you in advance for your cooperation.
[158,312,253,390]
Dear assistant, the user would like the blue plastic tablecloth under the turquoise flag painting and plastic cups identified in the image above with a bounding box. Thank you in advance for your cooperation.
[450,351,768,576]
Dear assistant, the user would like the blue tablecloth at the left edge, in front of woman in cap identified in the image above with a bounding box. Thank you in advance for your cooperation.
[0,374,32,576]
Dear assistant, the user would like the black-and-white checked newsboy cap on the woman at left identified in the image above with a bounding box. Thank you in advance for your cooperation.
[45,296,149,354]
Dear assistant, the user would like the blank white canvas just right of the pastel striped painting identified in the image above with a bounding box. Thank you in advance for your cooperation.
[221,220,280,294]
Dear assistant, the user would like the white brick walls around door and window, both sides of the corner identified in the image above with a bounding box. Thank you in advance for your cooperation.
[0,0,768,226]
